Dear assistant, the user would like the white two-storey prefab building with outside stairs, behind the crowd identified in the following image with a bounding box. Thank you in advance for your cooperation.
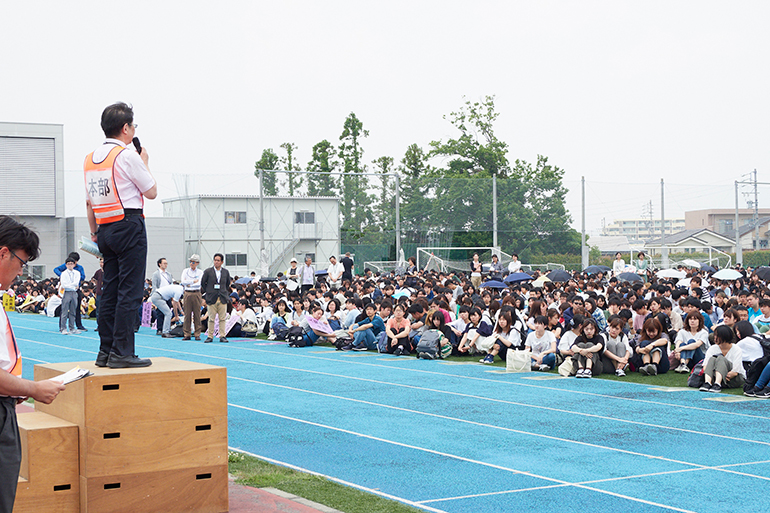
[163,194,340,276]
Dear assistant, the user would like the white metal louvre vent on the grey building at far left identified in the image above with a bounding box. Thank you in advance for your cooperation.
[0,137,56,216]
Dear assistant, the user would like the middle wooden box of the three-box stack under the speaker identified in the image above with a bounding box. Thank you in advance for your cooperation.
[80,417,227,477]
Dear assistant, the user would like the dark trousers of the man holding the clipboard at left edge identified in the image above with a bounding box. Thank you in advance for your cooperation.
[0,396,21,513]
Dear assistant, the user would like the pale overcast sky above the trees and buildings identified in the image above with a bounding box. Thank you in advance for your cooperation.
[0,0,770,233]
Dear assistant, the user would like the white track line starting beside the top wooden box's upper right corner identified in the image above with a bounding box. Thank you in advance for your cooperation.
[228,376,770,482]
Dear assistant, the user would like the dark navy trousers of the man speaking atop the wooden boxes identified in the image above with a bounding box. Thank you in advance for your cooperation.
[97,215,147,356]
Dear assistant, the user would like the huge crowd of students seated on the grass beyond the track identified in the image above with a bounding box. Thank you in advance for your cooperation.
[11,255,770,398]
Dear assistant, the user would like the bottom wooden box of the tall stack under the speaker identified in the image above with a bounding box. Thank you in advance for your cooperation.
[80,464,229,513]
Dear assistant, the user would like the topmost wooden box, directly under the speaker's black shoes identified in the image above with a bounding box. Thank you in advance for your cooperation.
[35,358,227,429]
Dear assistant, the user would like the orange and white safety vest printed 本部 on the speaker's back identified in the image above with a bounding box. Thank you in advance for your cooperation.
[83,145,125,224]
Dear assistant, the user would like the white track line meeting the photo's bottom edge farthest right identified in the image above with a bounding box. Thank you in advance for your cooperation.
[227,403,695,513]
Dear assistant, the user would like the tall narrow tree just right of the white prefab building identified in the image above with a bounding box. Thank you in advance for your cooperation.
[339,112,370,242]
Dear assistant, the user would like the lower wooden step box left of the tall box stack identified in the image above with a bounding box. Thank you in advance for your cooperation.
[13,412,80,513]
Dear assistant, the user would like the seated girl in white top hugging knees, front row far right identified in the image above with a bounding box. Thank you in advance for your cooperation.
[700,326,746,392]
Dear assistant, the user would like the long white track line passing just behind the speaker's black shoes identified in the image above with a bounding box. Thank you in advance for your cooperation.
[13,332,770,446]
